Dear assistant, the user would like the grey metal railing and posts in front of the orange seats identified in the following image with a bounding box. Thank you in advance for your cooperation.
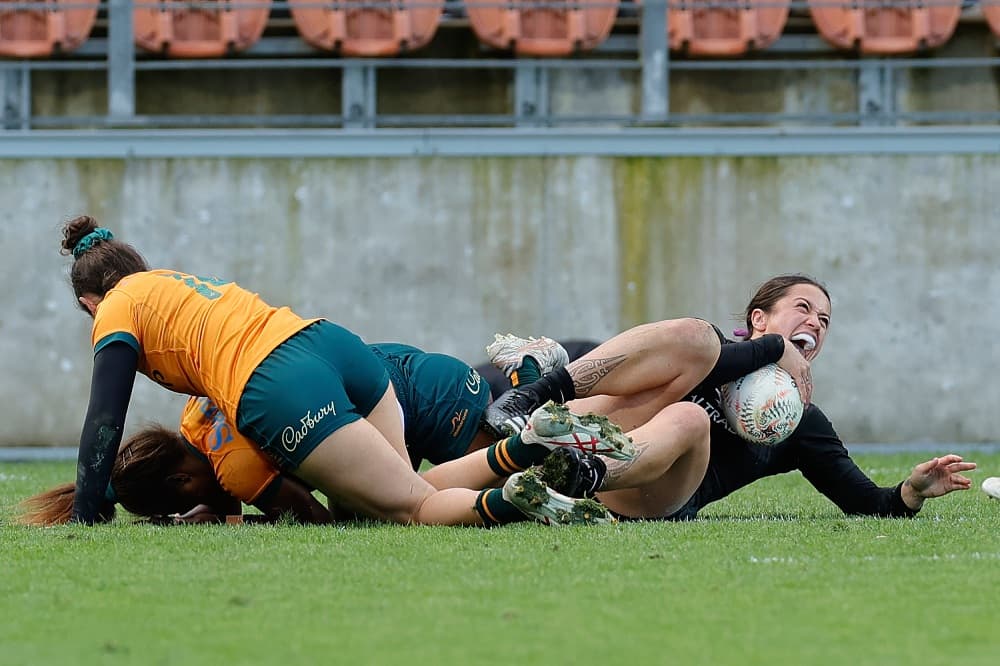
[0,0,1000,132]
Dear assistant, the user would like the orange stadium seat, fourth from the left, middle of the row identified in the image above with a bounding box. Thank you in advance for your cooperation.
[465,0,618,56]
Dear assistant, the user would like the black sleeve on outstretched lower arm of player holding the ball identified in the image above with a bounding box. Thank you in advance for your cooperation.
[793,406,917,518]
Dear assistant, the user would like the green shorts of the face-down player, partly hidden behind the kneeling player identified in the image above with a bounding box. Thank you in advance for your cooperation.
[371,343,490,469]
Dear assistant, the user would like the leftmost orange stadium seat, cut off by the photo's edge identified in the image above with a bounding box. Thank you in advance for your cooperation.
[0,0,98,58]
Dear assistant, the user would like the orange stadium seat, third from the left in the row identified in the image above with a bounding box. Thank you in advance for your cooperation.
[289,0,444,56]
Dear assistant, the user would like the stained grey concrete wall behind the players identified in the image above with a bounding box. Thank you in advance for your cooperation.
[0,156,1000,445]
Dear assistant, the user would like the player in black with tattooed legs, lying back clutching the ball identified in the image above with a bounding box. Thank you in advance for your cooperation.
[486,275,976,520]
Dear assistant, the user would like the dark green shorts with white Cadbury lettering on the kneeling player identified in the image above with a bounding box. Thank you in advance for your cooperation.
[236,320,389,471]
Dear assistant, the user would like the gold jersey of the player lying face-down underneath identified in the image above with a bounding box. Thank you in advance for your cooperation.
[181,398,279,504]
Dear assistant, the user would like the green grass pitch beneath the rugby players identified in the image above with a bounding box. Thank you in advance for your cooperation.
[0,453,1000,666]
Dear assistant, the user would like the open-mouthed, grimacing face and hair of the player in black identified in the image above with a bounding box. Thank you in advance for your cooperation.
[748,283,830,362]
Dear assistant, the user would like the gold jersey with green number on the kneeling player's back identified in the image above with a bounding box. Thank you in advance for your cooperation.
[91,270,316,423]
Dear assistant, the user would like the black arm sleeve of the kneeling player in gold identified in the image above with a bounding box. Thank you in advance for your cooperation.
[72,342,139,525]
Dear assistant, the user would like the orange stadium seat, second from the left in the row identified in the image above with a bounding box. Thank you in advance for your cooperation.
[132,0,271,58]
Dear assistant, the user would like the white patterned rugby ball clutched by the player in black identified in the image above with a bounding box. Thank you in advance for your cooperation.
[720,363,803,446]
